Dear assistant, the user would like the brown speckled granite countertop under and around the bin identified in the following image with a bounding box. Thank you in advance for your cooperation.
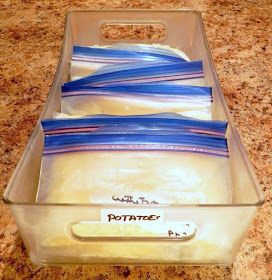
[0,0,272,280]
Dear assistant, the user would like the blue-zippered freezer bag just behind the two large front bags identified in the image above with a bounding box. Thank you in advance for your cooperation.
[61,84,212,119]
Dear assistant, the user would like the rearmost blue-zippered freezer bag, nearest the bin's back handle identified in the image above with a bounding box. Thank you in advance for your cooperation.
[71,44,189,80]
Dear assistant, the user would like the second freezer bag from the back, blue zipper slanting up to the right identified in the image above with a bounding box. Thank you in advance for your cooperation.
[64,61,205,86]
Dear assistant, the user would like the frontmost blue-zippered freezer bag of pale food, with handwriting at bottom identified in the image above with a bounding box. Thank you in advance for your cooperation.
[37,132,231,204]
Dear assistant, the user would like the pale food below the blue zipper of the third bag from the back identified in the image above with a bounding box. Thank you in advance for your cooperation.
[61,95,212,120]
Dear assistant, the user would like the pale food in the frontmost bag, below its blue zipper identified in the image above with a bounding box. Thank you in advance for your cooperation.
[37,151,231,204]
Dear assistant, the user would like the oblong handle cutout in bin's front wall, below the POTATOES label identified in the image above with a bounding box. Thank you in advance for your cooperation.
[68,220,196,242]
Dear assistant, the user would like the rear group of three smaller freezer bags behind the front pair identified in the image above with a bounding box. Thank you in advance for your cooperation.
[61,44,207,119]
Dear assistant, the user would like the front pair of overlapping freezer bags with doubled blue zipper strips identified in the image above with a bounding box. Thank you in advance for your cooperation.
[37,114,231,204]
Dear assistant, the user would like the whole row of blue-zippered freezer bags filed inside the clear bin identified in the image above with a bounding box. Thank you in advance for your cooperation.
[37,44,231,204]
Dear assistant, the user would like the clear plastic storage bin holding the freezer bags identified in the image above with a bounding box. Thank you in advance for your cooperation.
[4,10,263,264]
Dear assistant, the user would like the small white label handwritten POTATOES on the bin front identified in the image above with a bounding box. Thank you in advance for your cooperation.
[101,208,163,224]
